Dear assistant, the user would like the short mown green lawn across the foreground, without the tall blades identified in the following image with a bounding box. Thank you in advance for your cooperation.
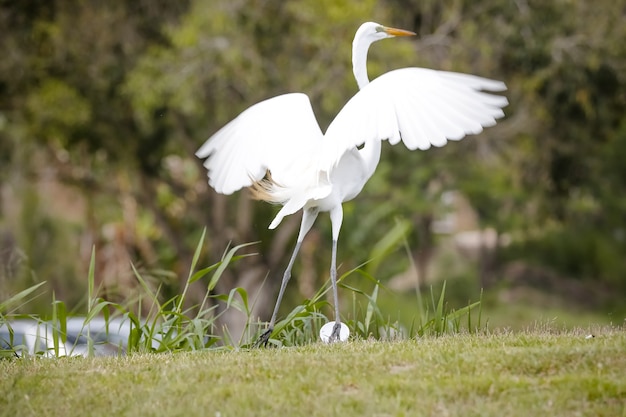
[0,327,626,417]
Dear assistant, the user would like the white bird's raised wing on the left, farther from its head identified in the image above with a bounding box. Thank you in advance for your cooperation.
[196,93,323,194]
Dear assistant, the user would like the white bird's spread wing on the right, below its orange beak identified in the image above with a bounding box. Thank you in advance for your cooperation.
[318,68,508,169]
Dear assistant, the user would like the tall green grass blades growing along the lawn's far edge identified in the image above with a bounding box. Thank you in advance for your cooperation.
[0,221,481,356]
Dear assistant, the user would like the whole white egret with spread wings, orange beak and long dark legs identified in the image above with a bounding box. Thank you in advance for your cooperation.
[196,22,508,343]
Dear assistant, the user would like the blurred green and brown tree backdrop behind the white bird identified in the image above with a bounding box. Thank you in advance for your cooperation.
[0,0,626,329]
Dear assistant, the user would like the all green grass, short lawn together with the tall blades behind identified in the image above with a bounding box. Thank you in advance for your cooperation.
[0,229,626,417]
